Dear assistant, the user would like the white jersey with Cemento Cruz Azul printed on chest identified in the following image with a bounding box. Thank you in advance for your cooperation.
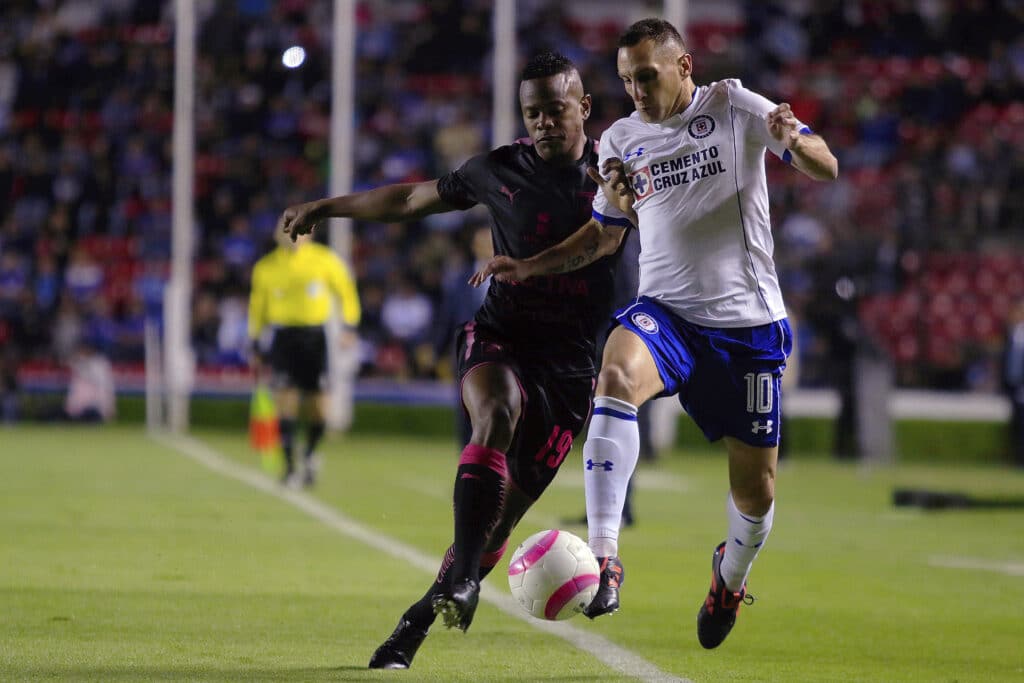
[594,79,809,328]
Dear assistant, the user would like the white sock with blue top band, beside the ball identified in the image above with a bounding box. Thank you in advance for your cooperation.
[583,396,640,557]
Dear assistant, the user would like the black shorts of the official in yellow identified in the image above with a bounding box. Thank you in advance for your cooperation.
[267,325,328,392]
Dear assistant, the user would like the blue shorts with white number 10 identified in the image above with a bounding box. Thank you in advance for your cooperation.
[615,297,793,447]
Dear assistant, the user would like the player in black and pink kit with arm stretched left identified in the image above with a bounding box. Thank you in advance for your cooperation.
[280,52,623,669]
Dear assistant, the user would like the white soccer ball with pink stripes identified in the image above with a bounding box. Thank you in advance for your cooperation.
[509,529,600,621]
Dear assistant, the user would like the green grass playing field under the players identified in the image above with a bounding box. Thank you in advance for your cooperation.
[0,427,1024,683]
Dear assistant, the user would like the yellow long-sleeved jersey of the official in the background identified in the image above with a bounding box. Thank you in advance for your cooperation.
[249,242,360,339]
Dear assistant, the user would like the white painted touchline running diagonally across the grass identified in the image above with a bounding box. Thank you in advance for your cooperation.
[150,432,693,683]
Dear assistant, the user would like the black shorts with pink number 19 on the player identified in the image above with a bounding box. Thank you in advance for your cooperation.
[457,323,595,501]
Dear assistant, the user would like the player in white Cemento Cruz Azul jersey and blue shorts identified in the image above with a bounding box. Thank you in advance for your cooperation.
[474,18,839,648]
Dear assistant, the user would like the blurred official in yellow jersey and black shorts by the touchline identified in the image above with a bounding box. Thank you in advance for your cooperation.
[249,230,360,486]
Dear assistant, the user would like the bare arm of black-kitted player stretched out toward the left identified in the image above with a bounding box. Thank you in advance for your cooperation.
[278,180,455,240]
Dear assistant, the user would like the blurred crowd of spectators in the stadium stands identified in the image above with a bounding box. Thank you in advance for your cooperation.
[0,0,1024,405]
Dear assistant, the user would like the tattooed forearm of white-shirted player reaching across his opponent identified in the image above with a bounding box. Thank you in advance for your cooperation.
[469,218,626,287]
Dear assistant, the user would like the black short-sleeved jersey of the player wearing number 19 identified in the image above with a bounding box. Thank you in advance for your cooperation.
[437,139,621,375]
